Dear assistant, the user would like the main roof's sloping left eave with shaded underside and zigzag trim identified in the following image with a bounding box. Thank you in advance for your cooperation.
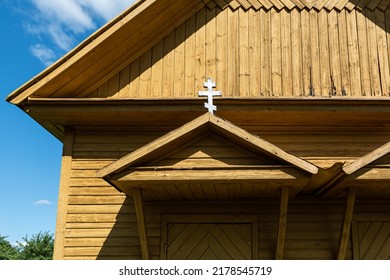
[7,0,390,105]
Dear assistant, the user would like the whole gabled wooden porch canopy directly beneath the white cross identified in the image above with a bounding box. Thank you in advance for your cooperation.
[98,113,319,200]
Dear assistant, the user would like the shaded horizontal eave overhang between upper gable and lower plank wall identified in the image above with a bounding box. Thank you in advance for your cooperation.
[21,97,390,142]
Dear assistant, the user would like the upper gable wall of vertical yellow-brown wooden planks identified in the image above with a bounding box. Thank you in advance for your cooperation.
[89,6,390,98]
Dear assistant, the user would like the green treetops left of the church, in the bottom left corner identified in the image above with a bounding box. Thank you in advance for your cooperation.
[0,232,54,260]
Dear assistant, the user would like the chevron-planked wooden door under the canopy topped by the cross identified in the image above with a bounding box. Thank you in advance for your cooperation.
[161,215,257,260]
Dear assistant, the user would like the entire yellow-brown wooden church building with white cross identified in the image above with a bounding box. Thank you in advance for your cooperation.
[7,0,390,260]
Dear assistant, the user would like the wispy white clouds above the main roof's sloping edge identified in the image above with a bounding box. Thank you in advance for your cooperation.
[24,0,135,66]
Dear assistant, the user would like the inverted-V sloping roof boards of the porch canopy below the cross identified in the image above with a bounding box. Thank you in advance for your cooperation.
[97,113,318,178]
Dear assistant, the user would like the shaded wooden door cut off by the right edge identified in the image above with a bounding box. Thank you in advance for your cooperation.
[353,217,390,260]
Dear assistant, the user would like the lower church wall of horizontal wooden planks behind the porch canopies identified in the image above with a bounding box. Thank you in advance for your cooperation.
[63,127,390,259]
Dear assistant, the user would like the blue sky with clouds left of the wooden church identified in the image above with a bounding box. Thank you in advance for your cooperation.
[0,0,134,243]
